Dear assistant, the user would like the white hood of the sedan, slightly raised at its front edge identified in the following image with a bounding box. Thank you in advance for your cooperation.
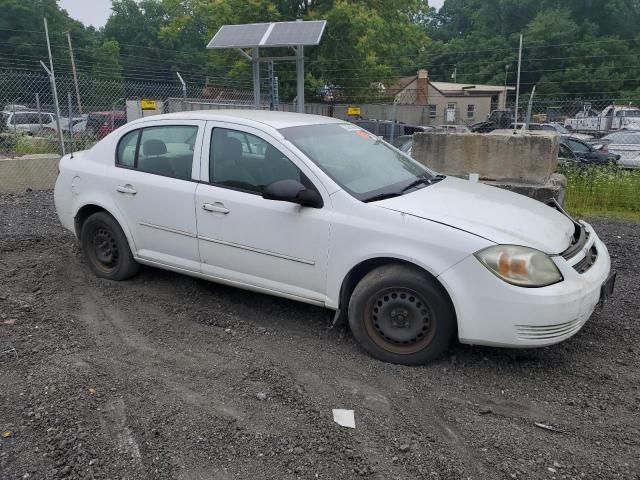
[372,177,575,254]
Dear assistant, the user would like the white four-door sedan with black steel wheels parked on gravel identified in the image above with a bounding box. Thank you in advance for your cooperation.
[55,110,615,365]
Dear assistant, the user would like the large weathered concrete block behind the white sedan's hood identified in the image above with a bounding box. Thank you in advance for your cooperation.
[412,132,560,184]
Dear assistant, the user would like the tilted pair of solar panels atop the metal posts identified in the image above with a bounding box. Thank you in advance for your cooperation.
[207,20,327,48]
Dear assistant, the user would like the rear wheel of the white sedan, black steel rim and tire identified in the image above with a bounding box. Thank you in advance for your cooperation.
[80,212,140,281]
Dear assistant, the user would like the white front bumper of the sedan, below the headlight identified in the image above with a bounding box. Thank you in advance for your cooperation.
[438,225,611,348]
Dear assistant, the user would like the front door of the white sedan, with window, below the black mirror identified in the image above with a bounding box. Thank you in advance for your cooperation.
[196,122,331,303]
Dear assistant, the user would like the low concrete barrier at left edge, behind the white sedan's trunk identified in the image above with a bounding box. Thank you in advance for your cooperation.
[0,154,60,193]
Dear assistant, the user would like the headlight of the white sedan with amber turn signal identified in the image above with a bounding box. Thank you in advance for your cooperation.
[474,245,563,287]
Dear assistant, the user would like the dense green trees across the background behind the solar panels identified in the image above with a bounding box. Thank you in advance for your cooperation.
[0,0,640,100]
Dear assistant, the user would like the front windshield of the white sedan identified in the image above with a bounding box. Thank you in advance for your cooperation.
[280,123,438,202]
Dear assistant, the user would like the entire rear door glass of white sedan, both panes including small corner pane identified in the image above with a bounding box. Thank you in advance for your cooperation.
[116,125,198,180]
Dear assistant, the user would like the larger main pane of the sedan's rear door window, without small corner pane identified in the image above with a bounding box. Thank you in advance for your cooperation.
[136,126,198,180]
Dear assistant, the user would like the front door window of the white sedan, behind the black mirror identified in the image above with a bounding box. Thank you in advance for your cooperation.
[209,128,309,194]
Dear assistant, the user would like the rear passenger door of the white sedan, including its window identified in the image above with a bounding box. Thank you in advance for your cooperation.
[111,120,205,272]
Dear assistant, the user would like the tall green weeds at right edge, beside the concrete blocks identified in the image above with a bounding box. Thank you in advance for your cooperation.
[562,165,640,220]
